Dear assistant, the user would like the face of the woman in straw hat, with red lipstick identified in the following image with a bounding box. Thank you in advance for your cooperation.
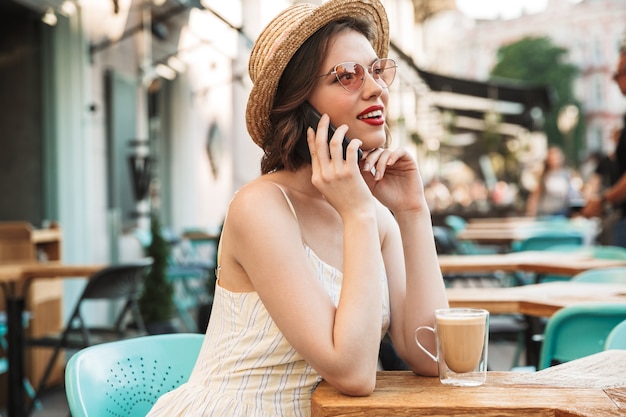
[309,30,389,151]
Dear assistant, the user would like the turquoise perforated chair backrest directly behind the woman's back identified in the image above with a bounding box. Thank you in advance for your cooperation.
[65,333,204,417]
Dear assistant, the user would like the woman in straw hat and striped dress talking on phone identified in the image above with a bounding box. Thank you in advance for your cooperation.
[149,0,447,417]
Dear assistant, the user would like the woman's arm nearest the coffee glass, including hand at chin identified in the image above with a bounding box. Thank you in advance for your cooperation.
[364,149,448,375]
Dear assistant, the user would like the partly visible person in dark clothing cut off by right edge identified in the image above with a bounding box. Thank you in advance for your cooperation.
[582,42,626,247]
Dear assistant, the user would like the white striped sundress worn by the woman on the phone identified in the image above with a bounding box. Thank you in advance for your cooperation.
[148,193,390,417]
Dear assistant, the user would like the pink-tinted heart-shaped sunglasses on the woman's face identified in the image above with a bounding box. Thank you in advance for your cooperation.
[318,58,398,91]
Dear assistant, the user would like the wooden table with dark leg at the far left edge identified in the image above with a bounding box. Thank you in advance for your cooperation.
[0,262,104,417]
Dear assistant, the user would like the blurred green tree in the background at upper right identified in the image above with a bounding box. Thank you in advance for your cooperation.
[491,37,584,165]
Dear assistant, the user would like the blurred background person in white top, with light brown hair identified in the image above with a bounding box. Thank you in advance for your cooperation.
[526,146,581,216]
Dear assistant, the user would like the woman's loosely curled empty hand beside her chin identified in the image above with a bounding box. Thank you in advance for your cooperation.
[361,148,427,213]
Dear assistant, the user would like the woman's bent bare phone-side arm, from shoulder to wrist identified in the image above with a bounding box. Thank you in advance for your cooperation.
[220,182,383,395]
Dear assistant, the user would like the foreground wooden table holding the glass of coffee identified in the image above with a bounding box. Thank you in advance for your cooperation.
[311,350,626,417]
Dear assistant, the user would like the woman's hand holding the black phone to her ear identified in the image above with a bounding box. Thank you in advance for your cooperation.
[307,114,374,217]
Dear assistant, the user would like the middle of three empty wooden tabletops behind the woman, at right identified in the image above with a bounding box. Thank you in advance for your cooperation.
[439,251,626,275]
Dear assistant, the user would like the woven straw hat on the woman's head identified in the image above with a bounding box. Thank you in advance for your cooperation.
[246,0,389,147]
